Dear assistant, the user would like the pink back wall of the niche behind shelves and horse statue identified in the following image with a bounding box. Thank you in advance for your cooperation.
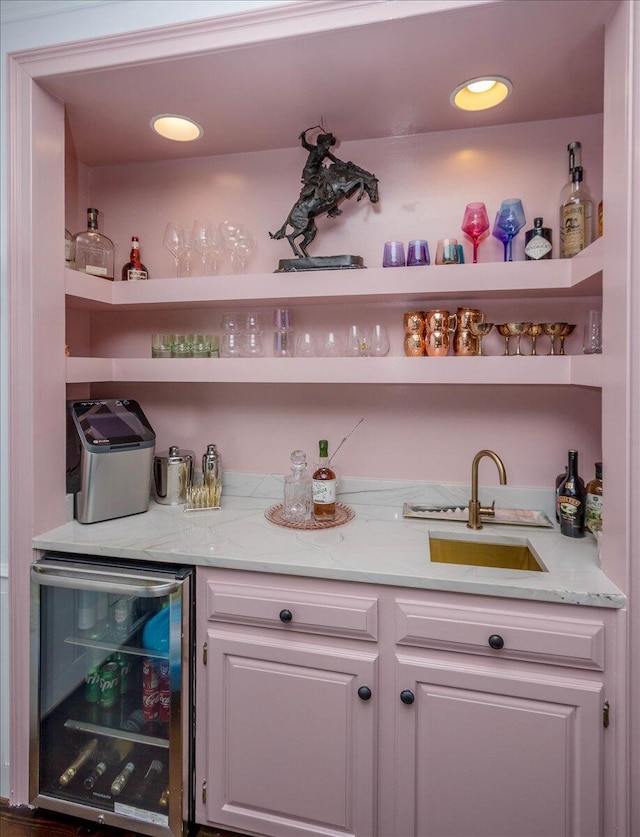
[67,115,602,486]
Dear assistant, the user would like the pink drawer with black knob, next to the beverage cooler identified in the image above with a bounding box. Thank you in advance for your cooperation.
[206,581,378,640]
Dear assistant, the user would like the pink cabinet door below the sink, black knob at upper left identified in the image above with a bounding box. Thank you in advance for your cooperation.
[395,658,603,837]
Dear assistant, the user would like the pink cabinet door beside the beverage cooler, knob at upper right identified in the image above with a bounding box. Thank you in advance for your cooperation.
[196,628,377,837]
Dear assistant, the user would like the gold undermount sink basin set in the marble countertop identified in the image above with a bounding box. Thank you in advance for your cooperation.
[429,536,545,573]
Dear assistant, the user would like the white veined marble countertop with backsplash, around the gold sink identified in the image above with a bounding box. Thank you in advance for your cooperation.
[33,472,625,608]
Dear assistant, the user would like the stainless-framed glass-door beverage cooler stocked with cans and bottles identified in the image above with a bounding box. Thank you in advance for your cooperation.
[30,554,194,837]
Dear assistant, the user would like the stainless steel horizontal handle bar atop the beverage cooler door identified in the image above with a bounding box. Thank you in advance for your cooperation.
[31,561,182,598]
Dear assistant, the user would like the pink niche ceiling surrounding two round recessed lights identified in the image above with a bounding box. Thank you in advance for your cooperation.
[27,0,615,166]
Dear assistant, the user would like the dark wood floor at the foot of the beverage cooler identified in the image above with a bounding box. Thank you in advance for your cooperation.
[0,799,248,837]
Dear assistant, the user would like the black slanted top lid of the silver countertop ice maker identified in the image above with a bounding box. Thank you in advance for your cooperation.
[71,398,156,452]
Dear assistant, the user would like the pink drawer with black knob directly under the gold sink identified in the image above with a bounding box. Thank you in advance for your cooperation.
[395,599,604,671]
